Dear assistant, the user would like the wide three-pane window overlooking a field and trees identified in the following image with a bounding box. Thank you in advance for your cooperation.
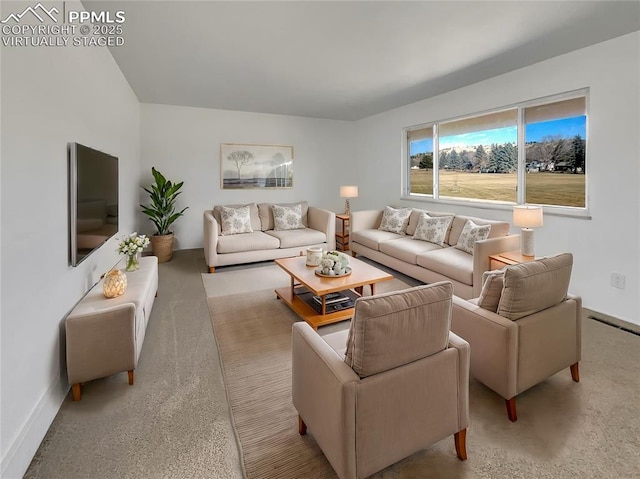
[403,90,587,208]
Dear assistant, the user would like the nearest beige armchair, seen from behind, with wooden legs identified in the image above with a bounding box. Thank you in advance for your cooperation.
[292,282,469,479]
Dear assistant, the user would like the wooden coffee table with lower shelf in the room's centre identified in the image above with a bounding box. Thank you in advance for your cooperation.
[275,256,393,330]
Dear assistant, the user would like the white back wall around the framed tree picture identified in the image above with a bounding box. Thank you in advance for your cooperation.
[139,104,357,249]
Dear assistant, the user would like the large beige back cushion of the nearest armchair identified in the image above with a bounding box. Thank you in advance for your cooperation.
[344,281,453,378]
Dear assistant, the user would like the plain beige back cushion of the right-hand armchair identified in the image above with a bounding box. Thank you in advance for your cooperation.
[498,253,573,321]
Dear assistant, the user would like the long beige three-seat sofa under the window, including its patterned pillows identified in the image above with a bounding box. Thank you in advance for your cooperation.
[349,206,520,299]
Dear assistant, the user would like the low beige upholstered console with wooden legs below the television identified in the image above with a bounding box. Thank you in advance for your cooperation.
[65,256,158,401]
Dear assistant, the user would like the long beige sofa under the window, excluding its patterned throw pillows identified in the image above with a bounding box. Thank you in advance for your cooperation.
[349,208,520,299]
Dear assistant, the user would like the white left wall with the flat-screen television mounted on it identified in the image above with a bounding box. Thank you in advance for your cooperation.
[0,2,140,478]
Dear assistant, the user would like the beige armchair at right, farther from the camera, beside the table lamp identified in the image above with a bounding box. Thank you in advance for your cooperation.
[451,253,582,421]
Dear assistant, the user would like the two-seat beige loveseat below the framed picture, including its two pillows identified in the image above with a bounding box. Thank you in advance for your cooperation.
[204,201,336,273]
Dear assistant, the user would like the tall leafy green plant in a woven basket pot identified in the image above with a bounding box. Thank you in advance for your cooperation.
[140,167,188,263]
